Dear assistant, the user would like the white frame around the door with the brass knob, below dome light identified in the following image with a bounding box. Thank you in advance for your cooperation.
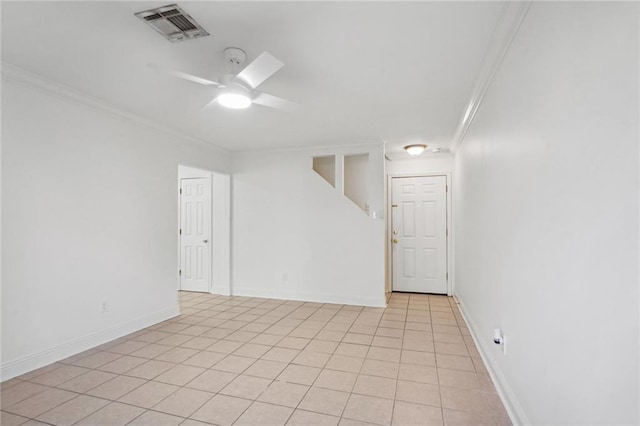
[385,172,455,296]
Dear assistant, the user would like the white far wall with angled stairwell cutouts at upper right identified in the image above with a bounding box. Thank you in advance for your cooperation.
[232,145,385,306]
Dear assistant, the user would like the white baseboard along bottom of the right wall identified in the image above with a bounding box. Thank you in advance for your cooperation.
[455,297,531,425]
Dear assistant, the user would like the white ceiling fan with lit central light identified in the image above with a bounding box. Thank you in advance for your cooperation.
[161,47,298,112]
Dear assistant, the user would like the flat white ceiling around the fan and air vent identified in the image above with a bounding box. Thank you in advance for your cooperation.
[2,0,502,151]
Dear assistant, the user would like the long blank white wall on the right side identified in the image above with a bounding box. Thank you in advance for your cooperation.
[454,2,639,424]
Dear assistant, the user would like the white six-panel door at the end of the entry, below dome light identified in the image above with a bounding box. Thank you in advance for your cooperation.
[391,176,447,294]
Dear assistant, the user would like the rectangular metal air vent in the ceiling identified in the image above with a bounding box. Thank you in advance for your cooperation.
[136,4,209,42]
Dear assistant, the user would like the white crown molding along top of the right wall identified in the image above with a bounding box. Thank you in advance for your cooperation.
[449,0,532,156]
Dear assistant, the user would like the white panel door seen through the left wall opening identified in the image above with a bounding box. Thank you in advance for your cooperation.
[180,178,211,292]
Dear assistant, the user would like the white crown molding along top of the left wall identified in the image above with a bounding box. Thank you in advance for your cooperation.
[0,61,229,155]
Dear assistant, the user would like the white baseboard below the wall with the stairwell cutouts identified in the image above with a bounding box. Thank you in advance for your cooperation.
[231,287,387,308]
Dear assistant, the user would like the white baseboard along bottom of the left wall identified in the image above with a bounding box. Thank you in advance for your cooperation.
[0,306,180,381]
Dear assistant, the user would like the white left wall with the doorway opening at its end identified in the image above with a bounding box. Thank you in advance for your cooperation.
[2,73,228,379]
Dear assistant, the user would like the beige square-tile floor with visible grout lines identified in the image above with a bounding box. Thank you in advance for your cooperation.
[0,292,510,426]
